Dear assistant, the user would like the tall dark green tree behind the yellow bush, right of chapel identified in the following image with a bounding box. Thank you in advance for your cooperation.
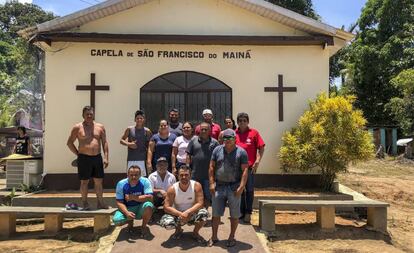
[344,0,414,125]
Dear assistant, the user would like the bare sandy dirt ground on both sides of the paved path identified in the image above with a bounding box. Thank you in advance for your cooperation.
[0,159,414,253]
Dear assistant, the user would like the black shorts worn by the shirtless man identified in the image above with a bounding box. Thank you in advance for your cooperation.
[78,154,104,180]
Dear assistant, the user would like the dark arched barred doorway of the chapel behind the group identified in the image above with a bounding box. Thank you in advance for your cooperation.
[140,71,232,131]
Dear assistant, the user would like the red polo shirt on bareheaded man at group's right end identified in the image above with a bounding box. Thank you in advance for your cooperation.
[236,128,265,167]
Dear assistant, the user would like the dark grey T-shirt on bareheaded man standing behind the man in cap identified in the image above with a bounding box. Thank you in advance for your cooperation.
[186,136,219,181]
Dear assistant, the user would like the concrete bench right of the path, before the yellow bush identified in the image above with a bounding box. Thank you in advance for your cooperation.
[259,200,389,232]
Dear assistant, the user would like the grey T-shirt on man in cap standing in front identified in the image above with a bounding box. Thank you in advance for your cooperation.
[211,145,248,183]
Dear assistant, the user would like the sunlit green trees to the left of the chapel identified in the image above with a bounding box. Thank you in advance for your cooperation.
[0,1,54,126]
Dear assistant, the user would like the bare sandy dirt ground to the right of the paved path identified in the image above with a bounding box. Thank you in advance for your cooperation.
[252,158,414,253]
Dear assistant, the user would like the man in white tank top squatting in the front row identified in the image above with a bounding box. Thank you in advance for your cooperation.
[160,165,208,243]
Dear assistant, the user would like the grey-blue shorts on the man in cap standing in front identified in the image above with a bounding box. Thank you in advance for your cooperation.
[212,182,241,219]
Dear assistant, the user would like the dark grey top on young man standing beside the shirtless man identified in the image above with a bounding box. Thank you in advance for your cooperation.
[127,126,152,161]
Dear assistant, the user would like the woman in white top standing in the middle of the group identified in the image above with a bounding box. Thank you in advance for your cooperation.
[171,121,193,176]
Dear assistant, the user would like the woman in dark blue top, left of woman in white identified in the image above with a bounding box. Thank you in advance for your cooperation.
[147,119,177,173]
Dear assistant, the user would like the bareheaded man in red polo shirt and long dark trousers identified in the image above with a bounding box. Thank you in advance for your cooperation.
[236,112,265,223]
